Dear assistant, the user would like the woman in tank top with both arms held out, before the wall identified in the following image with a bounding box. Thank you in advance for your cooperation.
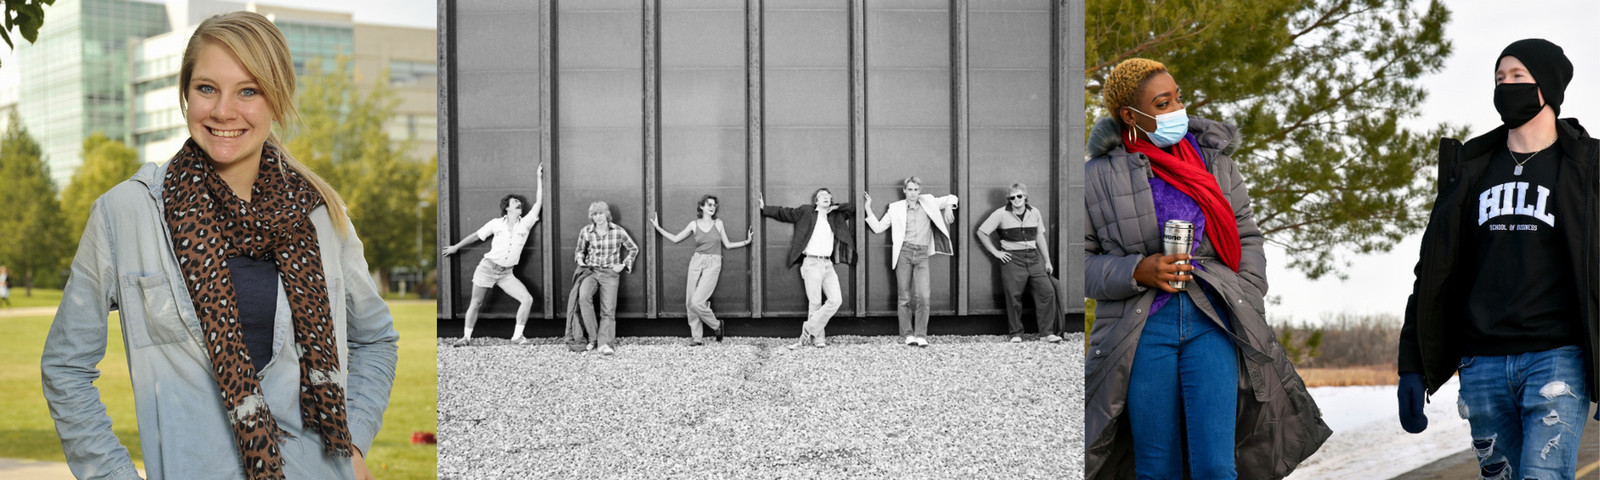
[650,195,755,347]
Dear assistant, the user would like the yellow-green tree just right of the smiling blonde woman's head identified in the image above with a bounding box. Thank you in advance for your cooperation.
[288,58,437,291]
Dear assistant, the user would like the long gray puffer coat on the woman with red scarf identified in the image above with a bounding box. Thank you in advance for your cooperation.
[1083,117,1333,478]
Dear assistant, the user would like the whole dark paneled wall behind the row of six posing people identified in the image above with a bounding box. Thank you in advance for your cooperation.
[438,0,1083,324]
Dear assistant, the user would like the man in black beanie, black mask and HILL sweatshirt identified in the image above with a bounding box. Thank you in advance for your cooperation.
[1398,38,1600,478]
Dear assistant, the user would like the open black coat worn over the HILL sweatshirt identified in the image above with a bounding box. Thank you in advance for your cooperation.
[1398,118,1600,400]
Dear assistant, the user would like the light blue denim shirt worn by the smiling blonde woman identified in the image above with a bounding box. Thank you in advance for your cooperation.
[40,163,400,480]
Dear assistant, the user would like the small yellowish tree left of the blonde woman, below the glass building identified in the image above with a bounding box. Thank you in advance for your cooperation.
[61,133,139,245]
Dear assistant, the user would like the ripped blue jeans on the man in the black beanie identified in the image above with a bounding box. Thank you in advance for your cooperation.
[1456,346,1589,480]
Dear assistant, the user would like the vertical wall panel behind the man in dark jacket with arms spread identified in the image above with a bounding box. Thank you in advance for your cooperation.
[752,0,853,315]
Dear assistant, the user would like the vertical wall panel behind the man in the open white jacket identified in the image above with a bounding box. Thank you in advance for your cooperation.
[853,0,960,315]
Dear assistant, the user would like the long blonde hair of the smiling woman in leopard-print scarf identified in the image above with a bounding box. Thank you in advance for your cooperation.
[178,11,350,235]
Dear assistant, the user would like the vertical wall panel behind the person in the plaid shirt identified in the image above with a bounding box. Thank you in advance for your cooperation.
[550,2,650,317]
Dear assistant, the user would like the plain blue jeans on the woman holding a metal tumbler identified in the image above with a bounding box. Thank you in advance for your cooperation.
[1126,294,1238,480]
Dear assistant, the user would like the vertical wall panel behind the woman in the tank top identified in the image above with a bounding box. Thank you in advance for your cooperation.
[648,0,754,317]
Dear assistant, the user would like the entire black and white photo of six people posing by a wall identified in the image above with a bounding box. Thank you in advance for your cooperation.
[437,0,1085,478]
